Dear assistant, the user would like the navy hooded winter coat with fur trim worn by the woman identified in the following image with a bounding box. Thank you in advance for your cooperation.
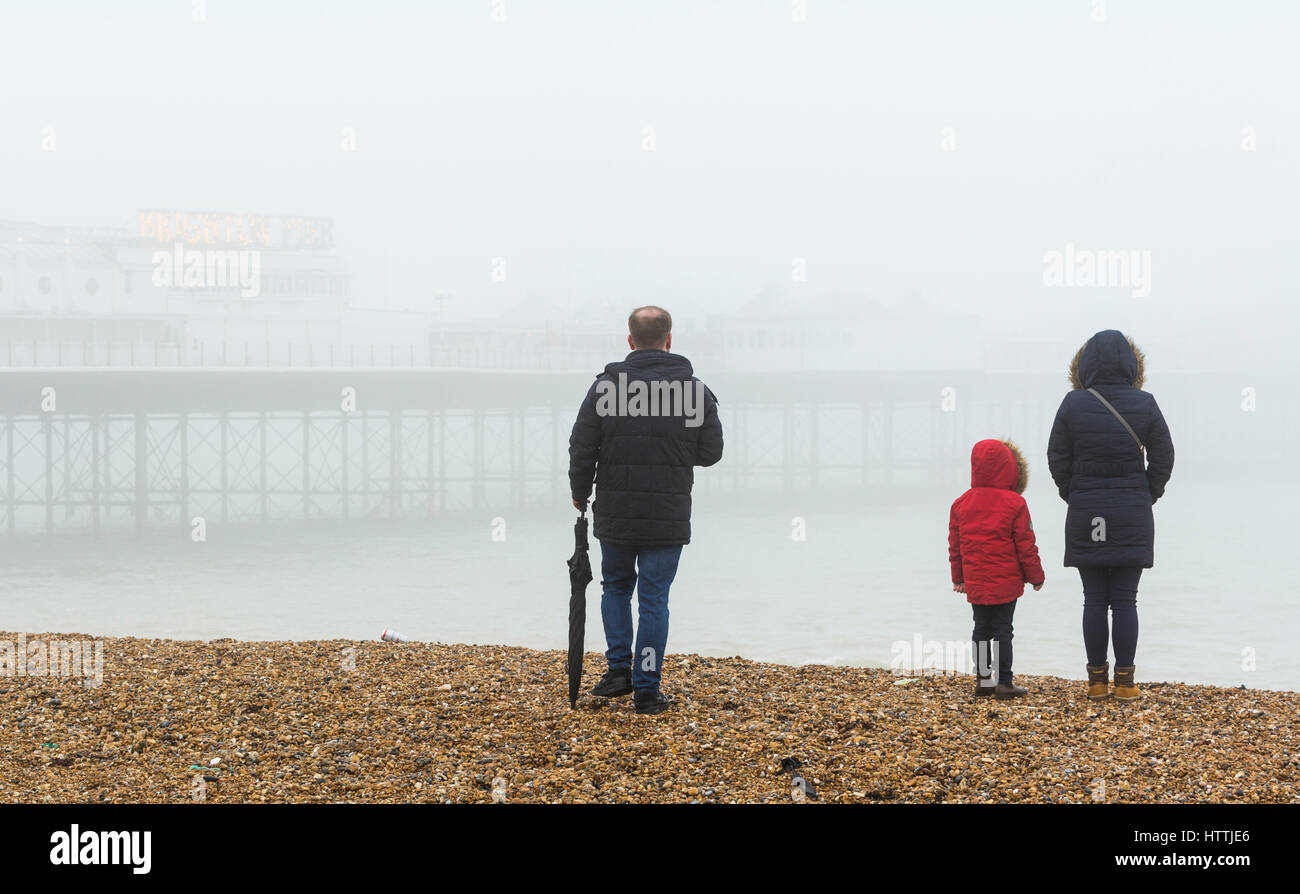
[1048,329,1174,568]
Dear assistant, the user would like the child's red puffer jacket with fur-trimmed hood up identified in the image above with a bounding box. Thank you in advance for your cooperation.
[948,439,1044,606]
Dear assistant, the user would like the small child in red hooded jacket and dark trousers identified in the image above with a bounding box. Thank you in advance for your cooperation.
[948,439,1045,699]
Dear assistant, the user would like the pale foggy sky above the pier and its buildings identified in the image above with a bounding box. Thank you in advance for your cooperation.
[0,0,1300,363]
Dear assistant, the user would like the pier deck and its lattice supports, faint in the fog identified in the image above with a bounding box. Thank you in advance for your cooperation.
[0,368,1300,538]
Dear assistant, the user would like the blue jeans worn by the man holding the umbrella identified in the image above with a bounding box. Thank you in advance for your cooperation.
[601,541,681,693]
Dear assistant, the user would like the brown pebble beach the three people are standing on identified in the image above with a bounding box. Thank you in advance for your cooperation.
[0,633,1300,806]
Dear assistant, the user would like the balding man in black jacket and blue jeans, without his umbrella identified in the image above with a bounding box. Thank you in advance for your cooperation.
[569,307,723,713]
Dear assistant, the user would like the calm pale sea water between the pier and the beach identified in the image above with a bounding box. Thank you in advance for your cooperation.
[0,479,1300,690]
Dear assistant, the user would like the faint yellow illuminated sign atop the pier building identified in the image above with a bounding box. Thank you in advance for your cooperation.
[139,211,334,251]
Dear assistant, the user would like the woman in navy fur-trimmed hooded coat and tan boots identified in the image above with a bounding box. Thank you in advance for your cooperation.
[1048,329,1174,702]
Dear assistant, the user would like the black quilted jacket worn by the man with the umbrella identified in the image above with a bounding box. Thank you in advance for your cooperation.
[569,350,723,546]
